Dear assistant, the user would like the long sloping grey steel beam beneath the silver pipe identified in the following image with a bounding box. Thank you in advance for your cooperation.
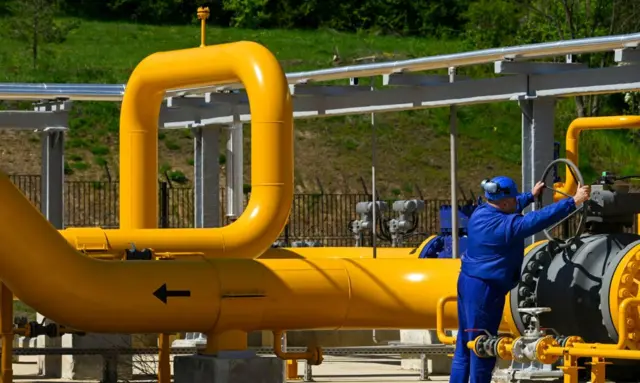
[160,63,640,128]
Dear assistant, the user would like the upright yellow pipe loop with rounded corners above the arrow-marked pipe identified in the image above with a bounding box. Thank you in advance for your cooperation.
[62,42,293,258]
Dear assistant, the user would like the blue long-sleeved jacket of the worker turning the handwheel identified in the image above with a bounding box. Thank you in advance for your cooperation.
[461,192,576,294]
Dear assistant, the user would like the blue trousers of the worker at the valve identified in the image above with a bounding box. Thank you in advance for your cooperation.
[449,273,506,383]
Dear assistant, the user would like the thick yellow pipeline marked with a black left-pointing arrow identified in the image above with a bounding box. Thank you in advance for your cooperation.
[0,172,508,334]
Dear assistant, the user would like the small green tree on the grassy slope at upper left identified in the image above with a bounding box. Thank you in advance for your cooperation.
[6,0,78,69]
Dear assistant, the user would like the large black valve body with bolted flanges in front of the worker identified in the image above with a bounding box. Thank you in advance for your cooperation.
[502,159,640,379]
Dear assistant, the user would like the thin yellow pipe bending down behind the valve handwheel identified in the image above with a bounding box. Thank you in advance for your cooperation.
[553,116,640,201]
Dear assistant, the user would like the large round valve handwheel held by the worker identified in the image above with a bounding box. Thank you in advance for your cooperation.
[536,158,587,249]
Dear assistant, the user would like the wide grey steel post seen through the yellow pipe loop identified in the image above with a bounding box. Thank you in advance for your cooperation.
[193,127,220,228]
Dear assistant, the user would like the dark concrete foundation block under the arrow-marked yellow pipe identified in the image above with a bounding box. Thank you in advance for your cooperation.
[173,354,285,383]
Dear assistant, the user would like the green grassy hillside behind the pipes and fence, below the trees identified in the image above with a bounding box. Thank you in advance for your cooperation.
[0,20,640,197]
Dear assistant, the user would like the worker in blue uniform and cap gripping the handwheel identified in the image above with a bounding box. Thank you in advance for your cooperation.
[449,176,589,383]
